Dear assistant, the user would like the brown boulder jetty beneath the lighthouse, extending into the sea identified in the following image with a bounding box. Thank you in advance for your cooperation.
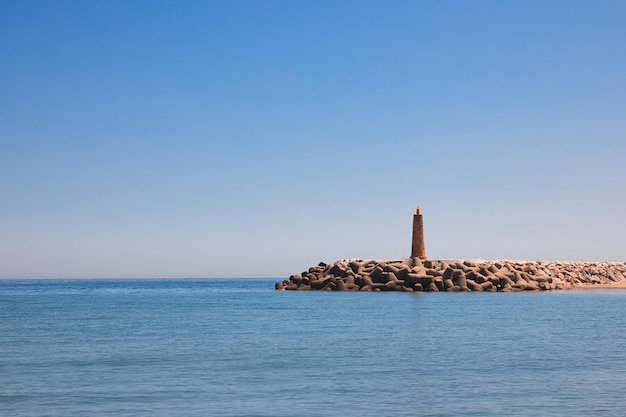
[275,258,626,292]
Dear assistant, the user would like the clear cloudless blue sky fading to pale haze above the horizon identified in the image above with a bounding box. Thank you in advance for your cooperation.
[0,0,626,278]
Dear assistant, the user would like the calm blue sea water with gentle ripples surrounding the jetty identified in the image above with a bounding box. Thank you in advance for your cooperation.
[0,279,626,417]
